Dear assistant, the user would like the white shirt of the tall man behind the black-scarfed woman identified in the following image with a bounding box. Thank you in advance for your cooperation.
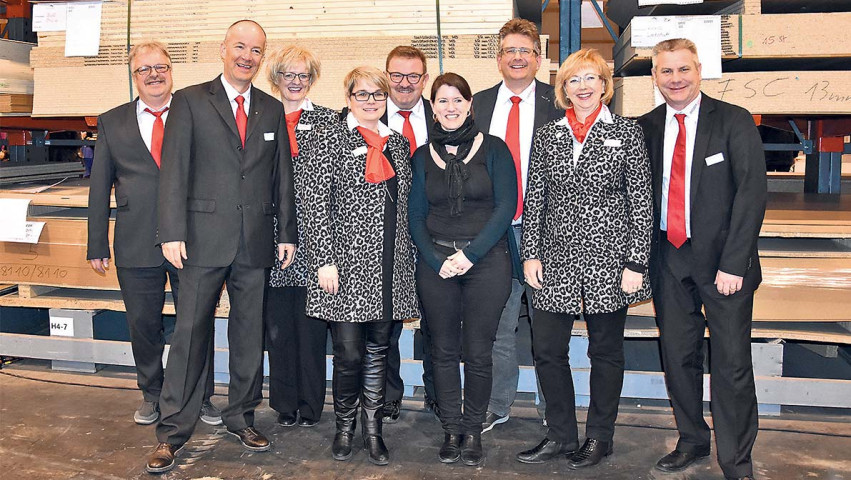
[488,80,536,225]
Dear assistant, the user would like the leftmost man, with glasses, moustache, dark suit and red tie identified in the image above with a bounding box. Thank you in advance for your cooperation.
[86,42,222,425]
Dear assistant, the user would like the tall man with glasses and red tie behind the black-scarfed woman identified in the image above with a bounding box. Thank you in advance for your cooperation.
[473,18,564,433]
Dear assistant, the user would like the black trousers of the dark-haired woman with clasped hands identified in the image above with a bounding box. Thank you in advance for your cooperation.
[416,242,511,434]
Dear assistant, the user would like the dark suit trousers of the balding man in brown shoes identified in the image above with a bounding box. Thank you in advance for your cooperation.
[157,241,266,445]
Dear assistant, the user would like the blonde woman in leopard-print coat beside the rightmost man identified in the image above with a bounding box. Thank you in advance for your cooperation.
[517,49,652,469]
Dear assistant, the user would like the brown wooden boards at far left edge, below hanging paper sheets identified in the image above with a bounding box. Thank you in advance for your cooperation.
[0,39,34,113]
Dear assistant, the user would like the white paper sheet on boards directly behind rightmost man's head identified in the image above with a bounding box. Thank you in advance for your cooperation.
[630,15,721,78]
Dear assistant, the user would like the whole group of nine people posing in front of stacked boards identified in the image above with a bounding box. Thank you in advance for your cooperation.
[88,15,766,478]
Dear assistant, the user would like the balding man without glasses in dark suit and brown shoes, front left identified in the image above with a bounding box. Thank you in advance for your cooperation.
[147,20,297,473]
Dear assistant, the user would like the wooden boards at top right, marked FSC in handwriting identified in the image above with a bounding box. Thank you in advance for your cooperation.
[613,0,851,117]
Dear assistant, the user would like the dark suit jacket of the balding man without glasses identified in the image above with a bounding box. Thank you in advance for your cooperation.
[158,77,297,267]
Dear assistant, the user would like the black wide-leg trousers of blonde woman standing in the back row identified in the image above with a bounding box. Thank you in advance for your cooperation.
[263,283,328,421]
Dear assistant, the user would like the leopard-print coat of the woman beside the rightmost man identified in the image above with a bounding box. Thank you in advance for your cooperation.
[521,107,653,314]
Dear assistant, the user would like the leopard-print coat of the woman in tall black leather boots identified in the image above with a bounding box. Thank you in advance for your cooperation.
[301,123,419,322]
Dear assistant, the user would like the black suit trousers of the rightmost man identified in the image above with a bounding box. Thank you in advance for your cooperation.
[653,242,759,477]
